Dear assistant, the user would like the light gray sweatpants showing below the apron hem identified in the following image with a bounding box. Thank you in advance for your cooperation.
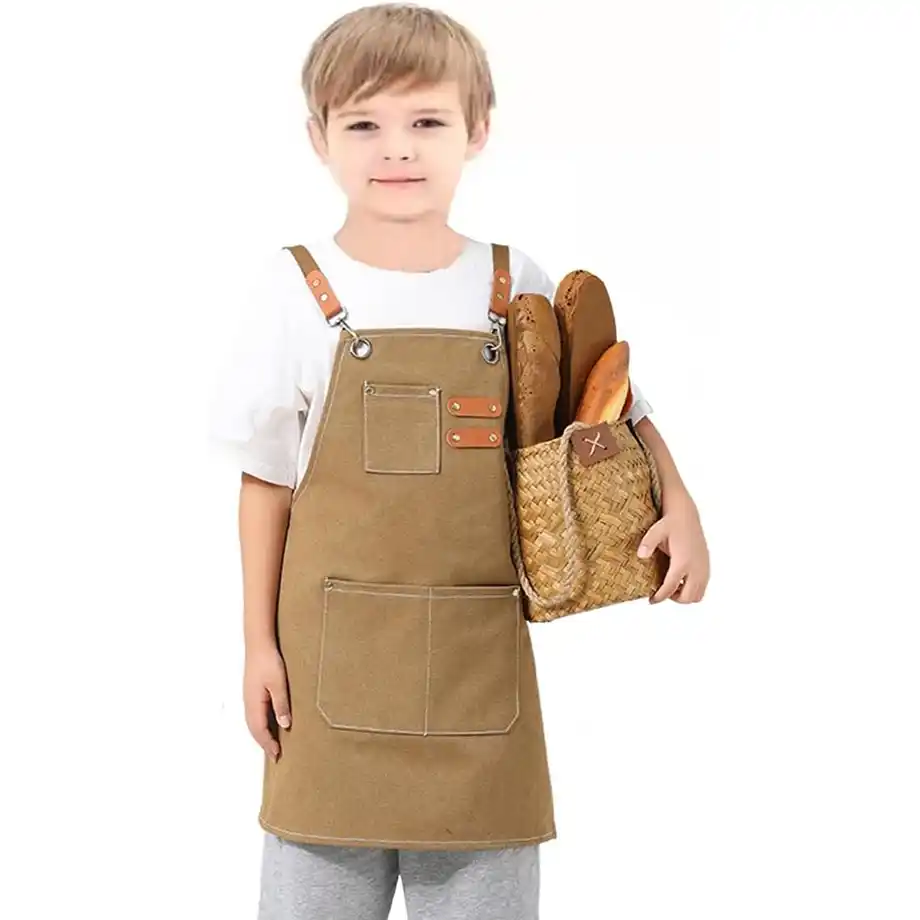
[258,832,540,920]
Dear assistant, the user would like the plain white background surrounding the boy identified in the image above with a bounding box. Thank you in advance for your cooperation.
[0,0,920,920]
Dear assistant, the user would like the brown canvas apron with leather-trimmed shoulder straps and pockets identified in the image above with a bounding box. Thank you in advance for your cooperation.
[259,245,556,850]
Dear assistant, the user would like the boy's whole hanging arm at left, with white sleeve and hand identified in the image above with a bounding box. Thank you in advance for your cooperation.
[210,249,311,759]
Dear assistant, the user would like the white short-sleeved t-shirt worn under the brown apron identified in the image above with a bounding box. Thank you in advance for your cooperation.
[210,237,652,489]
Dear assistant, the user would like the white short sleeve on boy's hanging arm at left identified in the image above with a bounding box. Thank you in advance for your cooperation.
[208,249,308,488]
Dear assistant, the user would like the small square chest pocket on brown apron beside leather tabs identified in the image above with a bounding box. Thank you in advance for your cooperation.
[362,380,441,473]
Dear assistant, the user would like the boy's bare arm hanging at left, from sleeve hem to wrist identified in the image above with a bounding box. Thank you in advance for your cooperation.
[239,473,293,655]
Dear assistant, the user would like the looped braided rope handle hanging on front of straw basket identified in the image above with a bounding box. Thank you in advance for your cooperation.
[505,422,591,609]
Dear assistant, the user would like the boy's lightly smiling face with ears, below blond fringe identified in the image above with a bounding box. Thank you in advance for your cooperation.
[309,81,488,221]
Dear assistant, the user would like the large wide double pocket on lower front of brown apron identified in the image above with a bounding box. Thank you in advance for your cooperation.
[316,578,522,735]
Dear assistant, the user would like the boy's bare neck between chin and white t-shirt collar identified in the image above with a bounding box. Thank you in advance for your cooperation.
[334,217,468,272]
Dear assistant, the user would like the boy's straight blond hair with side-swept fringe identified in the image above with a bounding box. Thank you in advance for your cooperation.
[301,3,495,132]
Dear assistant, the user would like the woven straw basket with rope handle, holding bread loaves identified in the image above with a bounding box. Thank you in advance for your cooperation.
[509,419,667,622]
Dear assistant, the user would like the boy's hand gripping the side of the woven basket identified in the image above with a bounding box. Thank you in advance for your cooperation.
[639,502,709,604]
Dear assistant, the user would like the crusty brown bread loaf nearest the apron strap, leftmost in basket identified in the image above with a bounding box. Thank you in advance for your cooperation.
[508,293,561,448]
